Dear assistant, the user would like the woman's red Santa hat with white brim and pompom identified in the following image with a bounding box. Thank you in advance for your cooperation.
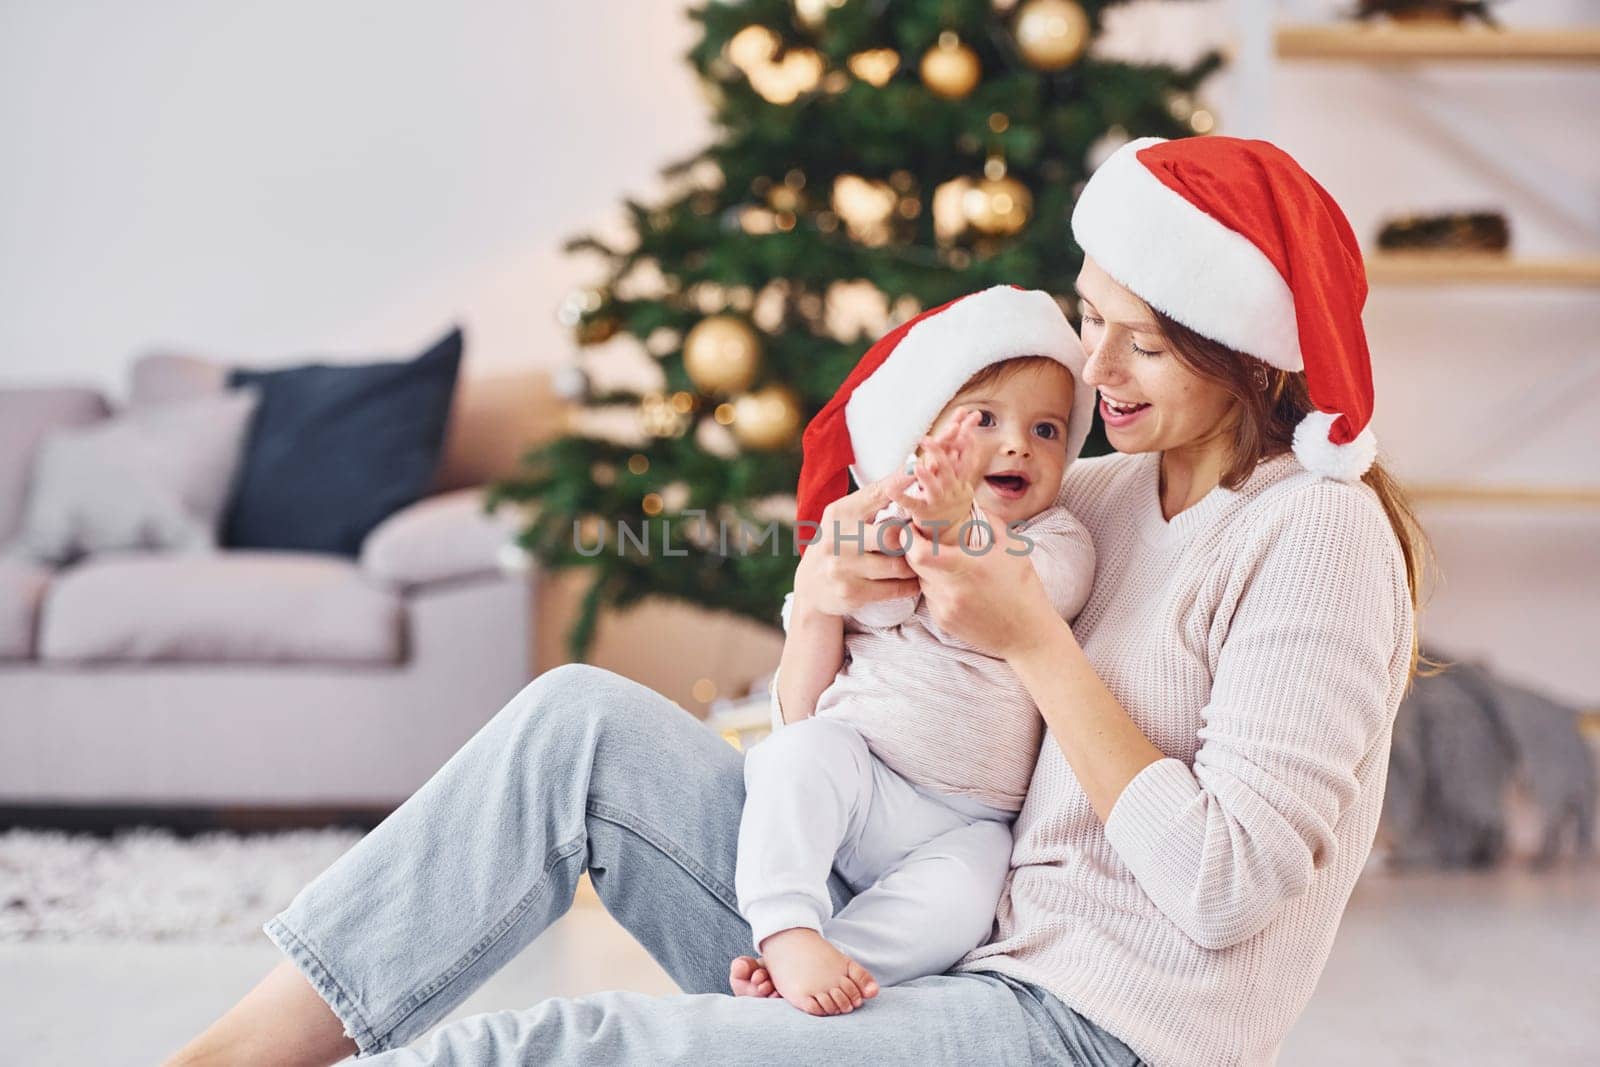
[1072,138,1378,482]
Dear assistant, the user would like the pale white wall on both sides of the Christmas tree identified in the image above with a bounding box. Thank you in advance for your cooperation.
[0,0,1600,704]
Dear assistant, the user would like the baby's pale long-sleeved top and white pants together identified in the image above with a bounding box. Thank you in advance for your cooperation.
[734,506,1094,985]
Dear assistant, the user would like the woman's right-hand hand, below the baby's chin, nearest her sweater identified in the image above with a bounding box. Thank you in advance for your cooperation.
[906,518,1070,661]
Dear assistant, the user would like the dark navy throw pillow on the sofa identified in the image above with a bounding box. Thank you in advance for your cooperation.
[222,328,462,555]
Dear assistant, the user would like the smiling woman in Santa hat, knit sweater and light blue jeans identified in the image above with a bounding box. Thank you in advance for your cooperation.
[174,138,1424,1064]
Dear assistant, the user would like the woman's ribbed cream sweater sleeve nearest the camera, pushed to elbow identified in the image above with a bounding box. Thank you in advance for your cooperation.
[1106,482,1413,949]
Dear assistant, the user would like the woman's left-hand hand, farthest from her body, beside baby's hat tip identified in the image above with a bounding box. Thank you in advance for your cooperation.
[792,472,918,616]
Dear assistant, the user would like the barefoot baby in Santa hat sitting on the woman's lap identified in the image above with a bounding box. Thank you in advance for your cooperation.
[730,286,1094,1014]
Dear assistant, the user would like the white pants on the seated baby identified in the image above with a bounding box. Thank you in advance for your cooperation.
[734,717,1016,985]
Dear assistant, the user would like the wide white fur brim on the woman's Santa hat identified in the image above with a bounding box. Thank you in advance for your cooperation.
[1072,138,1304,371]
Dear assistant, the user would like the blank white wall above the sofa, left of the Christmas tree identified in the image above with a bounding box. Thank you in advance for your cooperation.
[0,0,707,390]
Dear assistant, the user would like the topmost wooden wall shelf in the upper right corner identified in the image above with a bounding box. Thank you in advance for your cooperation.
[1274,24,1600,62]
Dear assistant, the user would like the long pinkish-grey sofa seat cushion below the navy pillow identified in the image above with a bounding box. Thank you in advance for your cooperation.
[38,550,405,664]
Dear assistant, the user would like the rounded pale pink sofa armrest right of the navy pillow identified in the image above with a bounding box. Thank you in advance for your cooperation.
[360,488,518,590]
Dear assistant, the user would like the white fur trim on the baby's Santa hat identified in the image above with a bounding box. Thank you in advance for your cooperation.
[845,285,1094,485]
